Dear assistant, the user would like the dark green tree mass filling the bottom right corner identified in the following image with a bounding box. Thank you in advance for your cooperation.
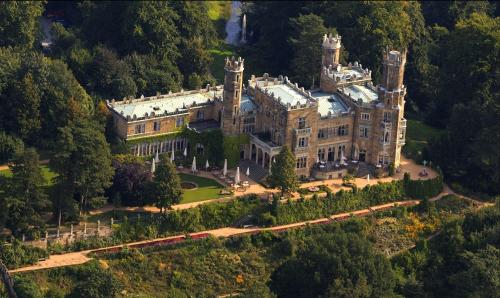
[393,206,500,297]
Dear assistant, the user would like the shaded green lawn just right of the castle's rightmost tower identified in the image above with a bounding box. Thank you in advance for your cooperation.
[403,119,443,163]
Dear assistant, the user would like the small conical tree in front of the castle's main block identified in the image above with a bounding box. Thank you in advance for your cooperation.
[270,146,299,195]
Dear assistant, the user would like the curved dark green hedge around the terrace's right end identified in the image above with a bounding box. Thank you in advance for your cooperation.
[403,169,443,199]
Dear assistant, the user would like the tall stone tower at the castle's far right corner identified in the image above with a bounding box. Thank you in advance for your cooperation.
[374,50,406,167]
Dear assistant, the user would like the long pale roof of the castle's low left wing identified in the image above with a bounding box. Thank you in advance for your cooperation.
[112,92,219,118]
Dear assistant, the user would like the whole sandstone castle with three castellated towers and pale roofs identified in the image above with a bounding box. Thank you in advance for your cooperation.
[107,35,406,178]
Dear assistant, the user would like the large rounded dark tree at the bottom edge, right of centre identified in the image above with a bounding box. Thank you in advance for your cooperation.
[270,229,395,297]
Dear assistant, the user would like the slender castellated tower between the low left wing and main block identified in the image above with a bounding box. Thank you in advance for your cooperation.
[221,57,245,135]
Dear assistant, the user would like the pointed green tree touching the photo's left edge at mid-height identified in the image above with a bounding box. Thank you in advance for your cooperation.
[1,148,50,235]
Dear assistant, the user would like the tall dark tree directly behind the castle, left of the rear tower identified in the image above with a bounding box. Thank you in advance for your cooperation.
[289,14,336,87]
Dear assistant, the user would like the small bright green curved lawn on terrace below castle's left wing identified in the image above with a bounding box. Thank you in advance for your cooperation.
[179,173,224,204]
